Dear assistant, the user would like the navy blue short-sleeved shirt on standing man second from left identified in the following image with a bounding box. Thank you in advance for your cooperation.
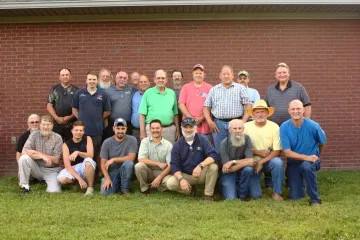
[71,88,111,136]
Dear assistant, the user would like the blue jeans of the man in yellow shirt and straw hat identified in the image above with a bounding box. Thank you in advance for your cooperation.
[250,157,284,198]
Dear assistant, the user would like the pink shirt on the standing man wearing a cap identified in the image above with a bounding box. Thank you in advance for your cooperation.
[179,82,212,134]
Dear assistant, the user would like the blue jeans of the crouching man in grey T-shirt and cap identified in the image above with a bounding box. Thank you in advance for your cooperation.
[100,160,134,195]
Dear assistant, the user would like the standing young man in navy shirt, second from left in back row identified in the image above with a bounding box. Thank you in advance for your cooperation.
[72,72,111,173]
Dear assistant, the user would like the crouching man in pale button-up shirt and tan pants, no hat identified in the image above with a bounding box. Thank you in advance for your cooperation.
[135,119,172,195]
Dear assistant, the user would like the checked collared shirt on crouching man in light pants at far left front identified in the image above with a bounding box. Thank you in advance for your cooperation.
[23,131,63,167]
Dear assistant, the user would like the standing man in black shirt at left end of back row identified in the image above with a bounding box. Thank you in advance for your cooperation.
[46,68,78,141]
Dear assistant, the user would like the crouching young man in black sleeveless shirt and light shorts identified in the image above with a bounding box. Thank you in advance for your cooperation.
[57,121,96,195]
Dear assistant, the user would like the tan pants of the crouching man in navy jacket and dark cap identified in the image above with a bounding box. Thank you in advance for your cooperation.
[167,163,218,196]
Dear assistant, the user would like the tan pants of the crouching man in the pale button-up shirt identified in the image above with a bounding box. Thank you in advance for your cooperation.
[135,163,170,192]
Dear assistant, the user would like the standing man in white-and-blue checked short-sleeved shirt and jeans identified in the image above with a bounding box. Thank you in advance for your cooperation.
[203,65,251,153]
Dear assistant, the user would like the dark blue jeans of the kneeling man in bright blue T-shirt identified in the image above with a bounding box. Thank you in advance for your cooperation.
[287,159,321,203]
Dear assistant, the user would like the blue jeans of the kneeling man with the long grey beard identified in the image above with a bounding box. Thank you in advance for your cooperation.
[220,166,254,200]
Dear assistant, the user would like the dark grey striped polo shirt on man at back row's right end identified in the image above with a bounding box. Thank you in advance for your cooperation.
[264,81,311,126]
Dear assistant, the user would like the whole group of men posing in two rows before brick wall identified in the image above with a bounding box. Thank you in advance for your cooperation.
[16,63,326,205]
